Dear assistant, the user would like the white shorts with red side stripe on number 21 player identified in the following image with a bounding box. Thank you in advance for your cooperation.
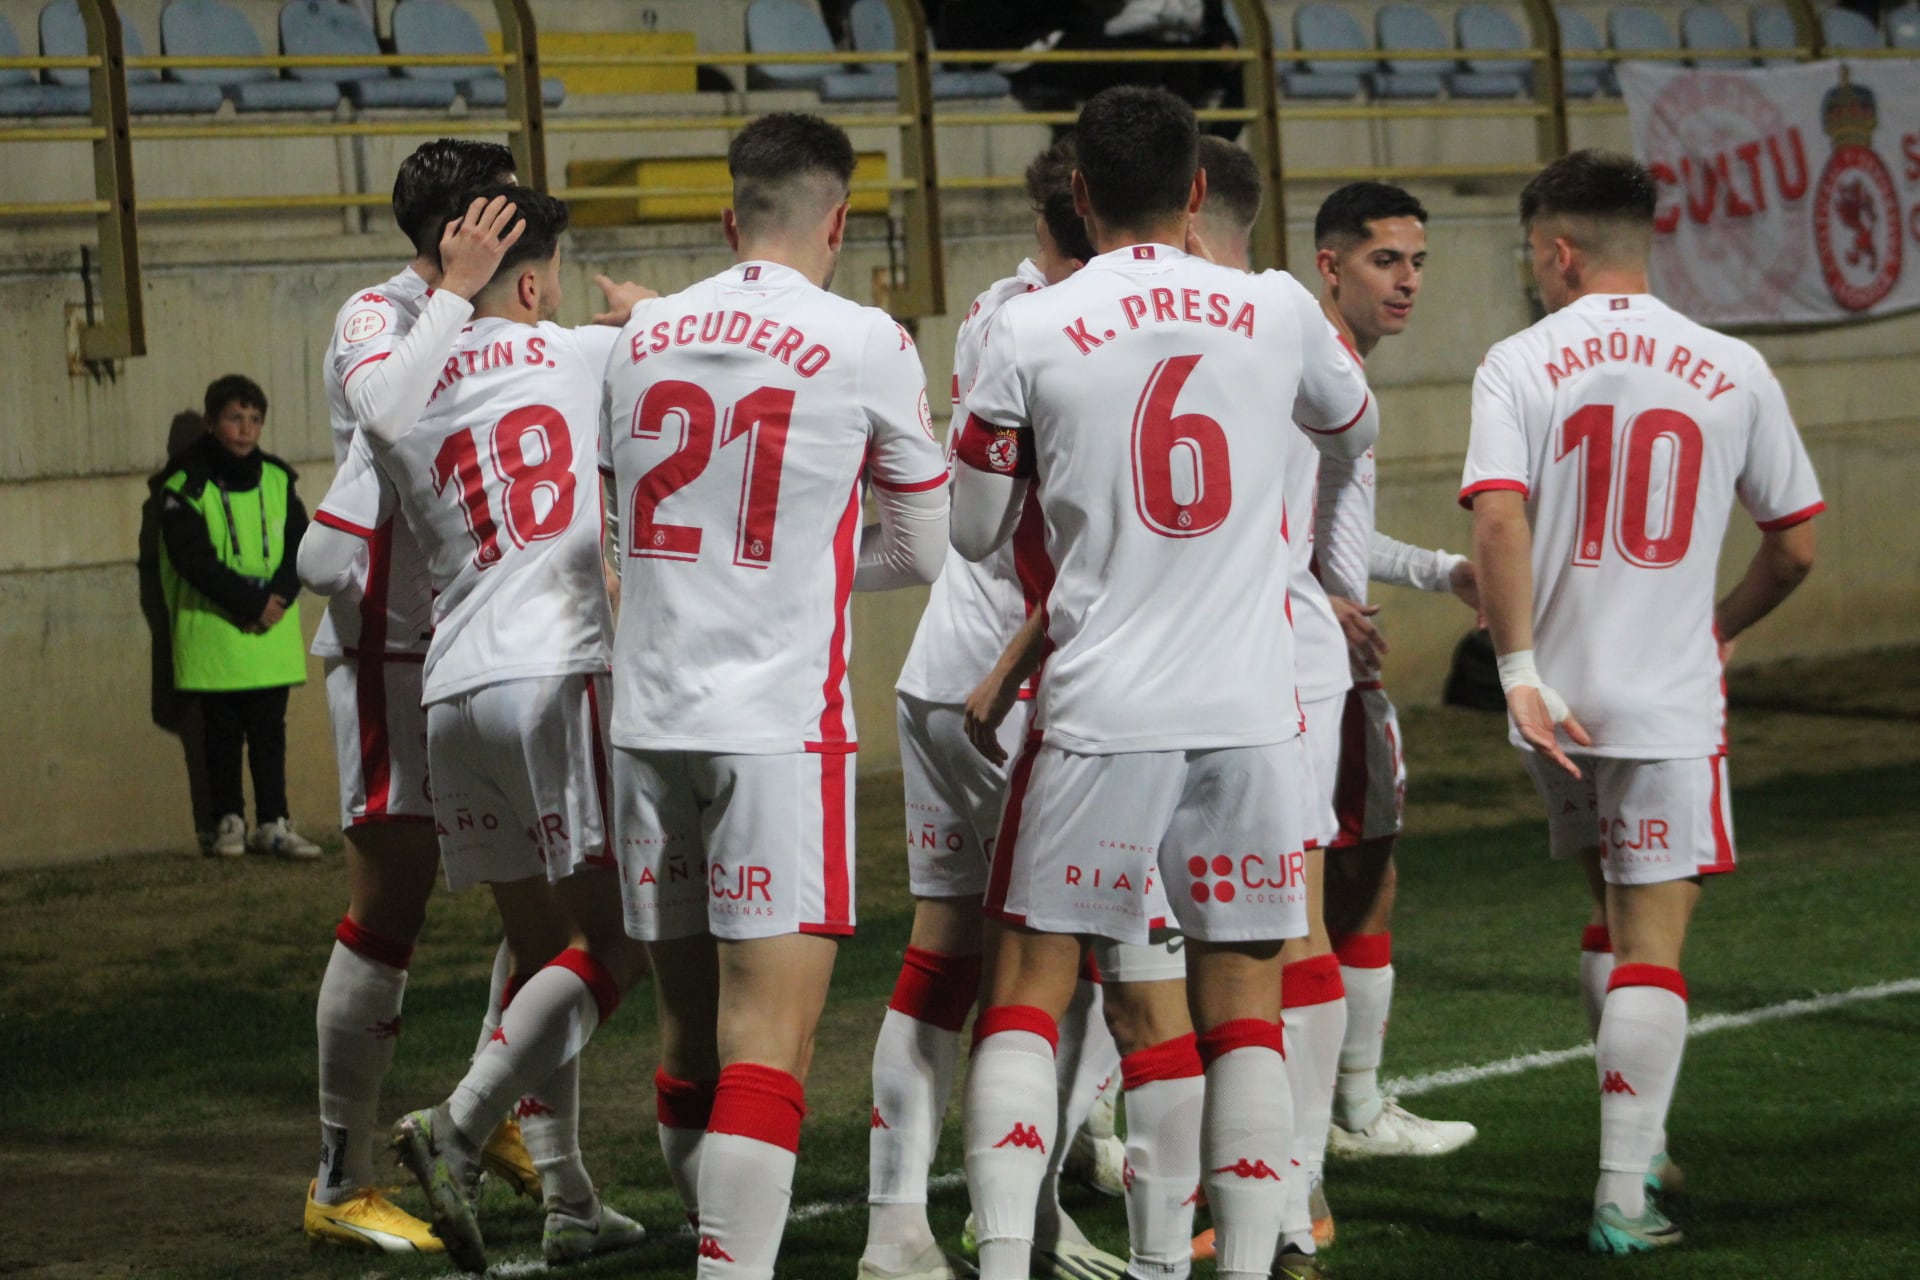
[612,747,854,942]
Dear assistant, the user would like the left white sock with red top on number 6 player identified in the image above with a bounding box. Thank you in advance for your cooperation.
[962,1006,1060,1280]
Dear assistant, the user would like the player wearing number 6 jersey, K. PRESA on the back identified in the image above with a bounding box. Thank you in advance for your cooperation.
[954,86,1371,1280]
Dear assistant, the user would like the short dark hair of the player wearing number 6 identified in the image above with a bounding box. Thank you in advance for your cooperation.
[1073,84,1200,230]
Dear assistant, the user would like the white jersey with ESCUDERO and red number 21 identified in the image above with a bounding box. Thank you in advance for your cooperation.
[601,263,947,754]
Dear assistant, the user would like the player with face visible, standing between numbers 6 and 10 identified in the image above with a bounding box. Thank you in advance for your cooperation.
[1308,182,1478,1157]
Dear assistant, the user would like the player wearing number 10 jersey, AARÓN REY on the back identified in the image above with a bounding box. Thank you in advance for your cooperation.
[1461,150,1824,1255]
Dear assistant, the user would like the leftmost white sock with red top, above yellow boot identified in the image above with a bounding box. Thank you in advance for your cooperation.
[313,921,413,1205]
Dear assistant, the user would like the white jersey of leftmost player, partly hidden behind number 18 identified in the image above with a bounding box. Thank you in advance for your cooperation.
[313,267,434,658]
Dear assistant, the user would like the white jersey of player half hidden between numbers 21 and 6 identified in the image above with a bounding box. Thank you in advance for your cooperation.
[895,259,1046,702]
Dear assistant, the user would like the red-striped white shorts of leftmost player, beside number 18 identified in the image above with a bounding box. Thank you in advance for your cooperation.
[326,654,434,831]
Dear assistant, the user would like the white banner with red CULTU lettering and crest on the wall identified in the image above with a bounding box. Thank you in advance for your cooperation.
[1620,59,1920,324]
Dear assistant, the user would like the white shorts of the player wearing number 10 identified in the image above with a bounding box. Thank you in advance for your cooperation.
[1523,750,1734,885]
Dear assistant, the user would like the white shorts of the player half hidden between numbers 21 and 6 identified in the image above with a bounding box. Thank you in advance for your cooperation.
[895,693,1033,898]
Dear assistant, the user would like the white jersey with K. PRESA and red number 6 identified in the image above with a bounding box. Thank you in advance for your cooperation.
[956,244,1367,754]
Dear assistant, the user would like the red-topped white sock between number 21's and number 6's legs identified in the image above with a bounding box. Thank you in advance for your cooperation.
[862,946,979,1270]
